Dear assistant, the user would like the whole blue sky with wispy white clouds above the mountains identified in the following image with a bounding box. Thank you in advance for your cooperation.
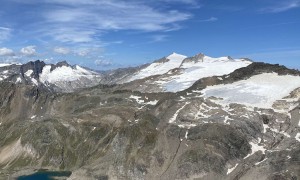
[0,0,300,69]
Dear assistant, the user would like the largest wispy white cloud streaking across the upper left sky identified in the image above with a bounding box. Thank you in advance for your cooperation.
[14,0,192,44]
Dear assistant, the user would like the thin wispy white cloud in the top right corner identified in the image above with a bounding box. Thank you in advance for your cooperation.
[260,0,300,13]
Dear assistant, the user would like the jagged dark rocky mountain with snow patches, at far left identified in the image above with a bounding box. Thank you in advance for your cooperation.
[0,60,101,92]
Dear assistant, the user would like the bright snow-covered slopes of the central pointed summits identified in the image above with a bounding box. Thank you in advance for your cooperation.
[127,53,252,92]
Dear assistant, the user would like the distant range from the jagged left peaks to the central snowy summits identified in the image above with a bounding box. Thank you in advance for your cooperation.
[0,53,252,92]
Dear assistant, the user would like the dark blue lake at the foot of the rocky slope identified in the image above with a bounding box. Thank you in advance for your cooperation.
[17,171,72,180]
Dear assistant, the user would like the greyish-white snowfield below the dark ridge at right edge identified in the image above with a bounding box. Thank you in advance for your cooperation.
[201,73,300,108]
